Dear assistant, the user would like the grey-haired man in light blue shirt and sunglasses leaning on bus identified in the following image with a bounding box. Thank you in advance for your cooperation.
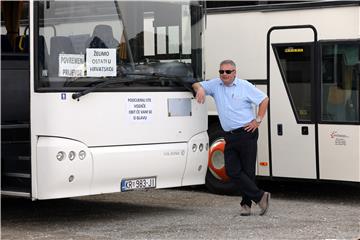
[192,60,270,216]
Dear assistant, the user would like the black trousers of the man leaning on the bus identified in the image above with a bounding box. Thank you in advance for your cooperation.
[224,128,264,207]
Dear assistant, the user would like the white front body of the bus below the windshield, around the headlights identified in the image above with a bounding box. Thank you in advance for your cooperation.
[31,92,208,199]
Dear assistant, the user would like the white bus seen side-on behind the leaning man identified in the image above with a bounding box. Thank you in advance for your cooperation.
[205,1,360,192]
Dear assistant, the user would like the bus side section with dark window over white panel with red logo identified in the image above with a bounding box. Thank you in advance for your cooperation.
[318,40,360,182]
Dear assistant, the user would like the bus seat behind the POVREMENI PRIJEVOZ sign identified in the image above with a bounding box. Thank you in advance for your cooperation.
[48,36,75,76]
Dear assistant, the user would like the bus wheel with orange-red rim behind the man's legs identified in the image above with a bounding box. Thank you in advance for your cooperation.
[205,125,239,195]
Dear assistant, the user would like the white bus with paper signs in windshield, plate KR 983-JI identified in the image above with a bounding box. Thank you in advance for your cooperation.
[1,1,208,200]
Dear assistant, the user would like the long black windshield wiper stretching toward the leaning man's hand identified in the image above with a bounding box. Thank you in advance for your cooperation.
[72,72,195,99]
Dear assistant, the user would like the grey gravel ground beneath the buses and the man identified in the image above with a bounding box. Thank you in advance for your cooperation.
[1,182,360,240]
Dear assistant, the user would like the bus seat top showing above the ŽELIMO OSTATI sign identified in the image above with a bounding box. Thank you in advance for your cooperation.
[86,24,119,48]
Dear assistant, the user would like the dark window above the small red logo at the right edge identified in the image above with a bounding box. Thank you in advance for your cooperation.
[321,42,360,122]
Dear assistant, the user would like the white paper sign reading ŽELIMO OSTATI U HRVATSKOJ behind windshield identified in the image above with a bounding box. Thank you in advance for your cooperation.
[86,48,116,77]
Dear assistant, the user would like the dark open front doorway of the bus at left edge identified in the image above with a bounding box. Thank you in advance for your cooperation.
[1,1,31,196]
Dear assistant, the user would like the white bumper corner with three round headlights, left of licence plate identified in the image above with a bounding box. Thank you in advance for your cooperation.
[33,137,93,199]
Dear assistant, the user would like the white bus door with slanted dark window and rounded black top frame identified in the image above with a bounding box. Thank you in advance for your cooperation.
[267,25,317,179]
